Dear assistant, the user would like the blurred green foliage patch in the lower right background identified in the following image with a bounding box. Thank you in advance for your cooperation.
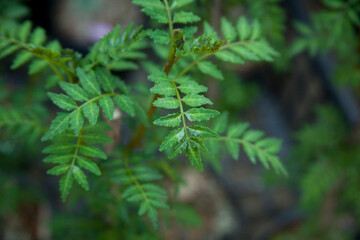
[272,106,360,239]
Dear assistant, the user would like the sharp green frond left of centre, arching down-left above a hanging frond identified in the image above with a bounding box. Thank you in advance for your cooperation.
[42,68,135,141]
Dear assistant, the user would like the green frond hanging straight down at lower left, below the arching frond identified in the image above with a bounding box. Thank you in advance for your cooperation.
[43,126,112,201]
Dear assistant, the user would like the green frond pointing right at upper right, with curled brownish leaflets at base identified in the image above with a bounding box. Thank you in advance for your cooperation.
[172,17,278,80]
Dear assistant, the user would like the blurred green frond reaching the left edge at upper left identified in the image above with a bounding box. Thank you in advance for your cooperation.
[0,21,76,81]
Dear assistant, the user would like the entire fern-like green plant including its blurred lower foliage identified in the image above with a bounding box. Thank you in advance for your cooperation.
[0,0,286,234]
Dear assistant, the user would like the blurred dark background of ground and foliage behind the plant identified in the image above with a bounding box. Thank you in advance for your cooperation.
[0,0,360,240]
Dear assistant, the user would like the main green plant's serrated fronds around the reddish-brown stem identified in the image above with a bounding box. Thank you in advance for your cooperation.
[0,0,286,234]
